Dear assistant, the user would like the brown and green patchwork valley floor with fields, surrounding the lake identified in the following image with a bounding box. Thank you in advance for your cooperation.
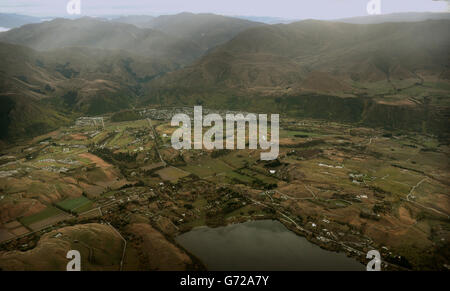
[0,111,450,270]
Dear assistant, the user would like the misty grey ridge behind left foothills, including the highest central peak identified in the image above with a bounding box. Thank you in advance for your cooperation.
[0,13,264,59]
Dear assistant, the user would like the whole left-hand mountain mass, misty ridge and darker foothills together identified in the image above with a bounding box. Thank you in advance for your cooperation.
[0,14,264,138]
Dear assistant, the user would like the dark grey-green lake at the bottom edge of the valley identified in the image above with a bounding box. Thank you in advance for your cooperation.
[176,220,365,271]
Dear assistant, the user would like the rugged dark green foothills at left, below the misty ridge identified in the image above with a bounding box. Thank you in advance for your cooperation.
[0,43,177,138]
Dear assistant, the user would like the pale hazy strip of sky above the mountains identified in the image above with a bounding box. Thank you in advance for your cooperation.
[0,0,449,19]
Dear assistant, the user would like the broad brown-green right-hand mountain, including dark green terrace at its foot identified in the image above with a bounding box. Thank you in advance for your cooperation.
[146,20,450,135]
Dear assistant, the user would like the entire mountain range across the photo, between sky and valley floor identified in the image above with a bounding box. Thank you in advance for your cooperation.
[0,13,450,139]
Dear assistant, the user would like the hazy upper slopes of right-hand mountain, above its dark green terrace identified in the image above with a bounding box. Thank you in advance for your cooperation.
[149,20,450,93]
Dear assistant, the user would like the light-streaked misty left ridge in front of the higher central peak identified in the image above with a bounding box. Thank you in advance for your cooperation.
[0,17,202,65]
